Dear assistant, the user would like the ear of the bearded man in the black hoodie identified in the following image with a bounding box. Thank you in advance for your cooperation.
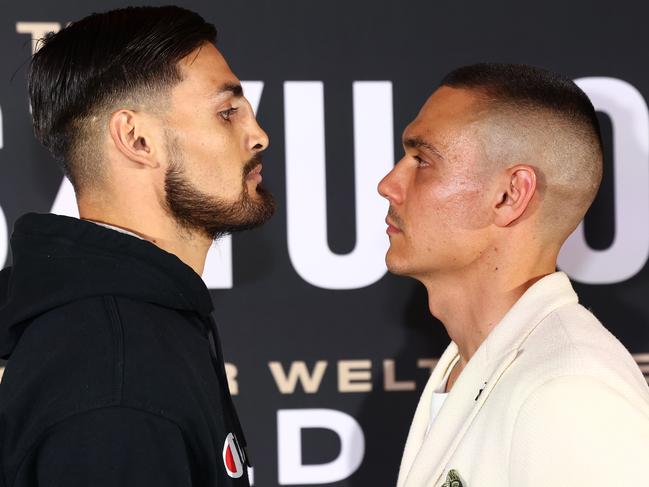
[108,110,159,167]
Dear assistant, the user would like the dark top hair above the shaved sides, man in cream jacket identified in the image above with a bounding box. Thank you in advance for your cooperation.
[440,63,601,151]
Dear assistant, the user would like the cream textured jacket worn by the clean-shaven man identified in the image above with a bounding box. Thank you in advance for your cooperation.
[397,272,649,487]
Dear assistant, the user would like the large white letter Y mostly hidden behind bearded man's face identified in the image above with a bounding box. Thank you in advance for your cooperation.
[203,81,264,289]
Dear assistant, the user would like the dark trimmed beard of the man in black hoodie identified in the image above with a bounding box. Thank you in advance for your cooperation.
[165,134,275,240]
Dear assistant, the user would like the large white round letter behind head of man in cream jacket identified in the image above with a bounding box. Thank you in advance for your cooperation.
[559,78,649,284]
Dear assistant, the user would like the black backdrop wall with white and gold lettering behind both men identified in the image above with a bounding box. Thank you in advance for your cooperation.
[0,0,649,487]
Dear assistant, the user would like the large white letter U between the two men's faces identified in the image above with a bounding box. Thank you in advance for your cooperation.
[284,81,394,289]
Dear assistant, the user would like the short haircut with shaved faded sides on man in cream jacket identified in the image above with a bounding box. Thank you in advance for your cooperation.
[441,63,603,241]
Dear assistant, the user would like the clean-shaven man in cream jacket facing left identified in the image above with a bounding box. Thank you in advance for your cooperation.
[379,64,649,487]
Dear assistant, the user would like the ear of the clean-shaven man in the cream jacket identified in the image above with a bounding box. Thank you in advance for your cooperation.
[494,164,536,227]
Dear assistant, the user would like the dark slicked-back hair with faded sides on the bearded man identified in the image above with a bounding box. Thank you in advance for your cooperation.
[28,6,216,192]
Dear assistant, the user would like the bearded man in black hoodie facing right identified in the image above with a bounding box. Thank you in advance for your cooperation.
[0,7,274,487]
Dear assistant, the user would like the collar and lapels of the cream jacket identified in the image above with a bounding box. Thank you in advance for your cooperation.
[397,272,577,487]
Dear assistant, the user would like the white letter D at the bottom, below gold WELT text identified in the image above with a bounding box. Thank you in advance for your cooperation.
[277,409,365,485]
